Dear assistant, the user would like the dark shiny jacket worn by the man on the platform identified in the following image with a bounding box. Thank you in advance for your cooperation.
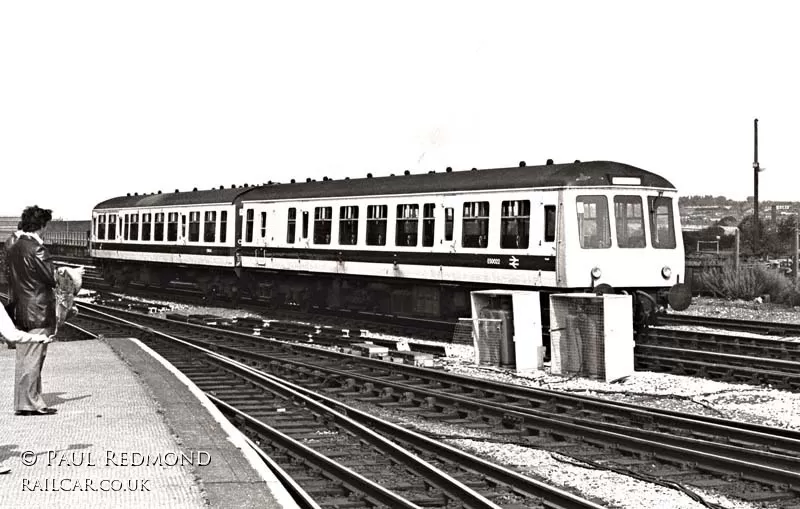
[7,235,56,331]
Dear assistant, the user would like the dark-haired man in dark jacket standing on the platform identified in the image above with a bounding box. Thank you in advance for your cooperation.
[7,205,56,415]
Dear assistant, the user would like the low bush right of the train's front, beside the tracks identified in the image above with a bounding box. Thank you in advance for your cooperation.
[699,263,800,306]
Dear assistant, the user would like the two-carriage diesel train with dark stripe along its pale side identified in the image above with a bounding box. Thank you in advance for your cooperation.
[90,161,688,321]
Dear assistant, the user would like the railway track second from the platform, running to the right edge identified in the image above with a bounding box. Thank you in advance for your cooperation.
[64,302,800,506]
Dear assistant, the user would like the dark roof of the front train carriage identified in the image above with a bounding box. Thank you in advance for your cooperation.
[241,161,675,201]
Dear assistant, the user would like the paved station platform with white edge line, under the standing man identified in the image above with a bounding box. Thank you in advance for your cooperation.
[0,338,296,509]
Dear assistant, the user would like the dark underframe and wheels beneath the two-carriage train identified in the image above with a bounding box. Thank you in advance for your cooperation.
[98,261,668,330]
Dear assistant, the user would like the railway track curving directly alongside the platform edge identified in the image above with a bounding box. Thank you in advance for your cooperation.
[67,302,601,509]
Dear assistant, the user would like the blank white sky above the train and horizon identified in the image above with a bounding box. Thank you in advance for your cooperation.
[0,0,800,219]
